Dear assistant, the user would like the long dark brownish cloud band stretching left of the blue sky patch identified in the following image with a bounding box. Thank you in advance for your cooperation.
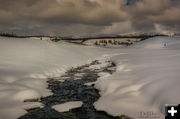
[0,0,126,25]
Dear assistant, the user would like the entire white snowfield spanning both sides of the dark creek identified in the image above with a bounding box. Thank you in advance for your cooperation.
[0,37,180,119]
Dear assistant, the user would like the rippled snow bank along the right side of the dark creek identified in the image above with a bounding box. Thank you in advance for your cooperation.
[94,37,180,119]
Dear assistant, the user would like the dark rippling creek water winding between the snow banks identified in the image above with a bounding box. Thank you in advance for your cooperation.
[19,61,131,119]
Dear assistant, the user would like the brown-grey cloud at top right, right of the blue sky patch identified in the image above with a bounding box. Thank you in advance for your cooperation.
[124,0,180,29]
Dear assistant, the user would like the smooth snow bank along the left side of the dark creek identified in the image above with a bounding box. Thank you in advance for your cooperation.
[0,37,114,119]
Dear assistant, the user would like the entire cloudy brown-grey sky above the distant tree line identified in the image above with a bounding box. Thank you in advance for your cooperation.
[0,0,180,36]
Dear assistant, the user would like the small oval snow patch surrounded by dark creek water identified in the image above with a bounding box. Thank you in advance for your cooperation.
[52,101,83,112]
